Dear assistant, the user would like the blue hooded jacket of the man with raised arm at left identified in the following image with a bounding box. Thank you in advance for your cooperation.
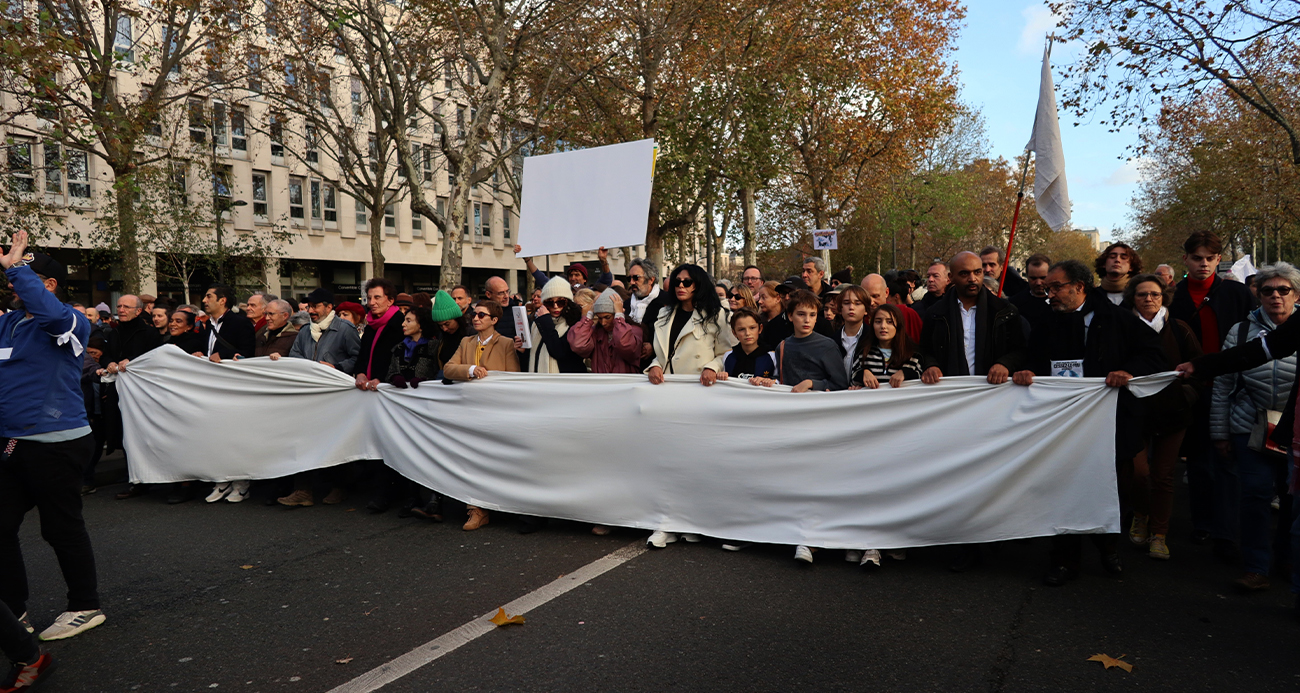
[0,267,90,438]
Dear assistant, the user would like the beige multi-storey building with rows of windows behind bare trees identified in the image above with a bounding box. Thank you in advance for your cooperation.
[0,7,644,306]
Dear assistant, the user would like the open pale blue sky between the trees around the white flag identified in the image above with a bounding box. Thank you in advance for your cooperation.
[954,0,1138,241]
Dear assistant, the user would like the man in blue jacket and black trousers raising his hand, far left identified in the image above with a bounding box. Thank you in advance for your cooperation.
[0,231,104,640]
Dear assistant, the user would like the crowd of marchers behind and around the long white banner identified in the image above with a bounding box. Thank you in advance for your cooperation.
[0,231,1300,686]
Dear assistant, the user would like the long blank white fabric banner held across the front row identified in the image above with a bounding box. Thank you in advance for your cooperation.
[118,347,1171,549]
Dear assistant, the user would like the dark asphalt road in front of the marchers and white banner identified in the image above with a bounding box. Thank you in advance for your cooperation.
[22,460,1300,693]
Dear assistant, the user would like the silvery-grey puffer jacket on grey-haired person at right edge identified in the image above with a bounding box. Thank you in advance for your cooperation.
[1210,308,1296,441]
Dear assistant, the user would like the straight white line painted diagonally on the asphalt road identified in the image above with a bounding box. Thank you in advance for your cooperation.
[329,540,646,693]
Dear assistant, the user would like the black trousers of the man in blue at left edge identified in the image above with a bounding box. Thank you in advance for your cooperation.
[0,434,99,614]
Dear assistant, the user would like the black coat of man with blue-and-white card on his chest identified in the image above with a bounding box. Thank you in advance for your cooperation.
[1027,293,1167,459]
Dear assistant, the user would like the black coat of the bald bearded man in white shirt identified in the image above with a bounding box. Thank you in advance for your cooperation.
[920,289,1024,376]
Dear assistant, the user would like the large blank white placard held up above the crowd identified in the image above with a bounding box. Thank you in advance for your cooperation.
[519,139,654,257]
